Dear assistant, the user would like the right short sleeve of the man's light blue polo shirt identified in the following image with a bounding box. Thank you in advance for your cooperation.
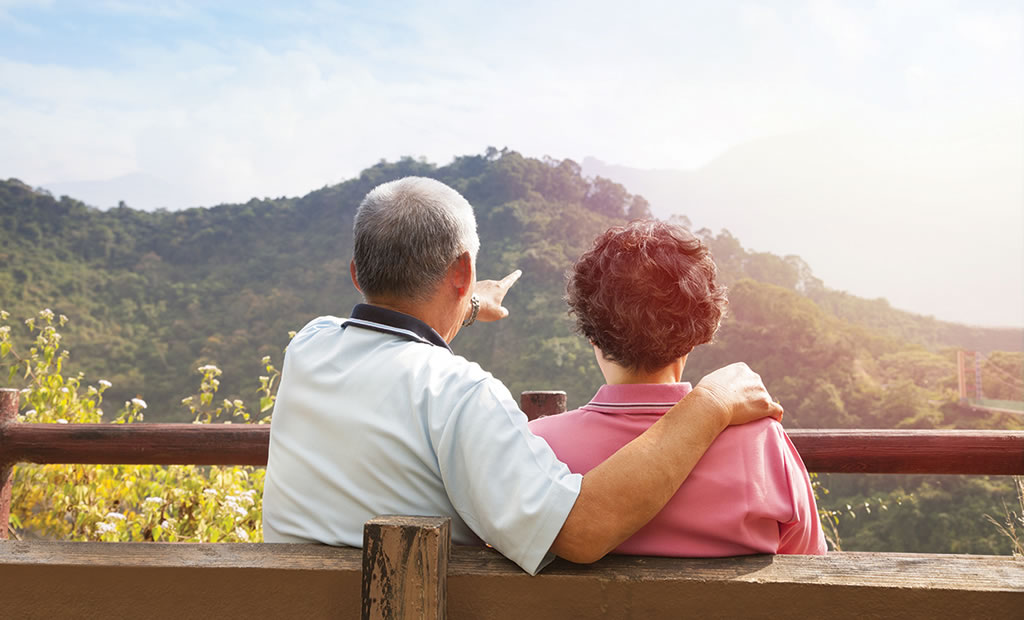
[432,377,583,575]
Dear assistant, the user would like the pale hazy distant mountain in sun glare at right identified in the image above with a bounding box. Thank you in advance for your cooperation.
[583,120,1024,327]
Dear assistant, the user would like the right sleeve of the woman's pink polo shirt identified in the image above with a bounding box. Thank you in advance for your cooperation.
[778,426,827,555]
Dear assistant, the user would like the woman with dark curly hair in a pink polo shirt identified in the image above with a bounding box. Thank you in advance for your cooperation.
[529,220,825,557]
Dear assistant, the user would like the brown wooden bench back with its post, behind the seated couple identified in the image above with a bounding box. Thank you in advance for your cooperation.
[0,518,1024,620]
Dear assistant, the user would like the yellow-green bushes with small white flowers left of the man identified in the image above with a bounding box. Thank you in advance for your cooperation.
[0,309,278,542]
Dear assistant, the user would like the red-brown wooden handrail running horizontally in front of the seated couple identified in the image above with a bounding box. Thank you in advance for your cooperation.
[0,390,1024,474]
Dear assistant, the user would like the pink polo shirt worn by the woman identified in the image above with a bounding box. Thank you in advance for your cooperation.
[529,383,826,557]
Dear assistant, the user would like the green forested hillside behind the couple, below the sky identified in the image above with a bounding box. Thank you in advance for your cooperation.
[0,150,1024,552]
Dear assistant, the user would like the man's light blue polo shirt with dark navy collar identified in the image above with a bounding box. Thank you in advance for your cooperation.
[263,304,583,574]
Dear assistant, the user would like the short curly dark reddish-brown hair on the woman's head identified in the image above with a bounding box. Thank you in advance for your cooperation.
[566,220,728,372]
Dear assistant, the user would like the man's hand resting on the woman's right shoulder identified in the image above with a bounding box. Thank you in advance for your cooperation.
[693,362,782,424]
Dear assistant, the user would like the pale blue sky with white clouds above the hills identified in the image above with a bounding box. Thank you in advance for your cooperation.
[0,0,1024,326]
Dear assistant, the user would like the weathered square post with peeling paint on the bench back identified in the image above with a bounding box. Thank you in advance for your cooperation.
[362,516,452,620]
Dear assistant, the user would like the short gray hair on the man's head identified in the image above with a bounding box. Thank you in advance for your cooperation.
[353,176,480,299]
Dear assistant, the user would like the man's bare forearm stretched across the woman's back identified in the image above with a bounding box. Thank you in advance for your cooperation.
[551,389,729,563]
